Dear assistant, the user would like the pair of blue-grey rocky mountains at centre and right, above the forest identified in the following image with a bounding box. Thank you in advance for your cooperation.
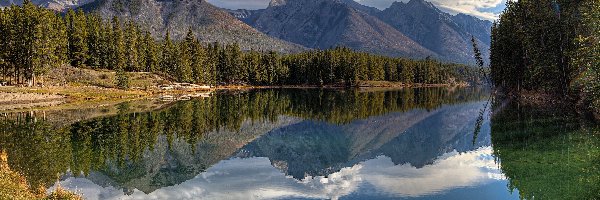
[230,0,492,64]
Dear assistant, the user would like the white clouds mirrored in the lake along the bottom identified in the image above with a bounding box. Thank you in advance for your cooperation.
[51,147,518,199]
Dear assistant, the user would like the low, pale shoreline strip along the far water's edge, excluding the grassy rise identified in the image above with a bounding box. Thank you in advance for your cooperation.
[0,82,469,112]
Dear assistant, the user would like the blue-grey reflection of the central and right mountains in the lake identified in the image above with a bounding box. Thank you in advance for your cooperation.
[238,101,490,179]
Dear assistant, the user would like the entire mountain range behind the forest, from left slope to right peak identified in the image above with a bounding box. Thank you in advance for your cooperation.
[0,0,492,64]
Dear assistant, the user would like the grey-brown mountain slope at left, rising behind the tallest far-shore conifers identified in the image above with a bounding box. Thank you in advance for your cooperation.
[31,0,305,53]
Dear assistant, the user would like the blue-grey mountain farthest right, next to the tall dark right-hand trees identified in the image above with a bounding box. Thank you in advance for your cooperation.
[377,0,492,63]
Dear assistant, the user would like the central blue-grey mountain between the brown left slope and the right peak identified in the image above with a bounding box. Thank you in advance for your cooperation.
[244,0,436,58]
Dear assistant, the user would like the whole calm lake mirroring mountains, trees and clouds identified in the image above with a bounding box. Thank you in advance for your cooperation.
[0,88,600,199]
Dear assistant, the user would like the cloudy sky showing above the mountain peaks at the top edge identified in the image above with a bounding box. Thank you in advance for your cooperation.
[208,0,506,20]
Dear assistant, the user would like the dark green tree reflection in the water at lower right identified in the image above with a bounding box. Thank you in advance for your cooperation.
[491,102,600,199]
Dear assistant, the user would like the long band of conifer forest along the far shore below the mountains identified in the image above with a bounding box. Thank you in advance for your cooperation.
[0,1,485,88]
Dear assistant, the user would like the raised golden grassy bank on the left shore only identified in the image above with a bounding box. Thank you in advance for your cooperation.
[0,66,192,111]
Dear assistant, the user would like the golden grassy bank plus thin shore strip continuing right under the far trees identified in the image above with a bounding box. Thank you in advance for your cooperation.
[0,66,468,111]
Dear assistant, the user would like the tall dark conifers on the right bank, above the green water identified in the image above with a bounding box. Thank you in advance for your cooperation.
[490,0,600,109]
